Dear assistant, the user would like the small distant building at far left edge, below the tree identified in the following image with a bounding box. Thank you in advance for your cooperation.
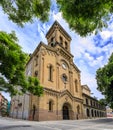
[0,93,8,116]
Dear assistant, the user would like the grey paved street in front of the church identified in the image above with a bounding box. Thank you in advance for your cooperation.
[0,117,113,130]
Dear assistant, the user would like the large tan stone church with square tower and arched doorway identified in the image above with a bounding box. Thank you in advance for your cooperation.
[11,21,105,121]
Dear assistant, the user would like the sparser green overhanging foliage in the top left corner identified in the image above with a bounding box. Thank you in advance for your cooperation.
[0,0,50,26]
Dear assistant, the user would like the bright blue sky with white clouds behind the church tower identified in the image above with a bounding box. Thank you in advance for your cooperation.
[0,0,113,100]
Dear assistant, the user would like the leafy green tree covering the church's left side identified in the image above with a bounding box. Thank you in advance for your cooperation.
[0,31,43,96]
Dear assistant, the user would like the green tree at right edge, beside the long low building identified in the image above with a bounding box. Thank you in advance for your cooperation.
[96,53,113,108]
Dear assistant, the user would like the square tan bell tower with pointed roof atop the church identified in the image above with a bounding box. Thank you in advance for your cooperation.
[46,21,71,52]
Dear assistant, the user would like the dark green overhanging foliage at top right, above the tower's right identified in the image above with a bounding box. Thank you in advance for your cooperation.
[57,0,113,36]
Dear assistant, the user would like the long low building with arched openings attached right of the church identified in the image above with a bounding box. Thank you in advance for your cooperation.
[82,85,106,118]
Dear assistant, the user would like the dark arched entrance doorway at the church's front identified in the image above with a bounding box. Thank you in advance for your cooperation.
[62,103,71,120]
